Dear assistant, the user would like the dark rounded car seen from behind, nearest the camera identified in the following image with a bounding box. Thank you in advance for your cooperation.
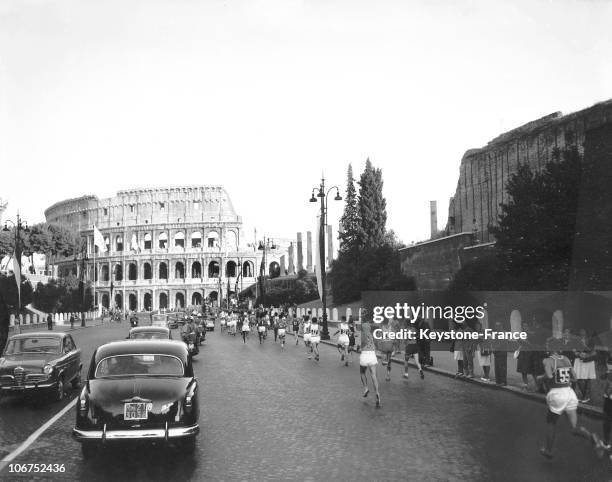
[72,340,200,458]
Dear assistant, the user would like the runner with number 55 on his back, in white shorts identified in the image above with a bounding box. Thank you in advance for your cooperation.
[538,339,599,458]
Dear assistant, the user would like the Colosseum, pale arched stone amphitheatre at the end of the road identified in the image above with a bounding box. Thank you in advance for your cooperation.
[45,186,280,310]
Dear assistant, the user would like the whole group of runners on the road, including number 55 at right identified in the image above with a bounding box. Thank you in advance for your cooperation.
[219,310,612,461]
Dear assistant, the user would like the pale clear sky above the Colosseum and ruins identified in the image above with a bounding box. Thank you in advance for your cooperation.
[0,0,612,247]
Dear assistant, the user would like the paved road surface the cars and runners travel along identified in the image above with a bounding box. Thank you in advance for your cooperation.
[0,325,612,481]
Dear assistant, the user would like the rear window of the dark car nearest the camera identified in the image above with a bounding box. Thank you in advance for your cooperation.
[95,354,184,378]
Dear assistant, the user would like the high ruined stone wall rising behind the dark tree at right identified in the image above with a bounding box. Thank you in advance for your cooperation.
[446,100,612,242]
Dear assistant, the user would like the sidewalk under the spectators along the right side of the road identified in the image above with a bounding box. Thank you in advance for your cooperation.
[290,327,604,419]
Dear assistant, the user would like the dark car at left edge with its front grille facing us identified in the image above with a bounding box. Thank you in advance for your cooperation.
[0,331,82,400]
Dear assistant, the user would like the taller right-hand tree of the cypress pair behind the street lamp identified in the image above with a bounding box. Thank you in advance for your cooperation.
[357,158,387,249]
